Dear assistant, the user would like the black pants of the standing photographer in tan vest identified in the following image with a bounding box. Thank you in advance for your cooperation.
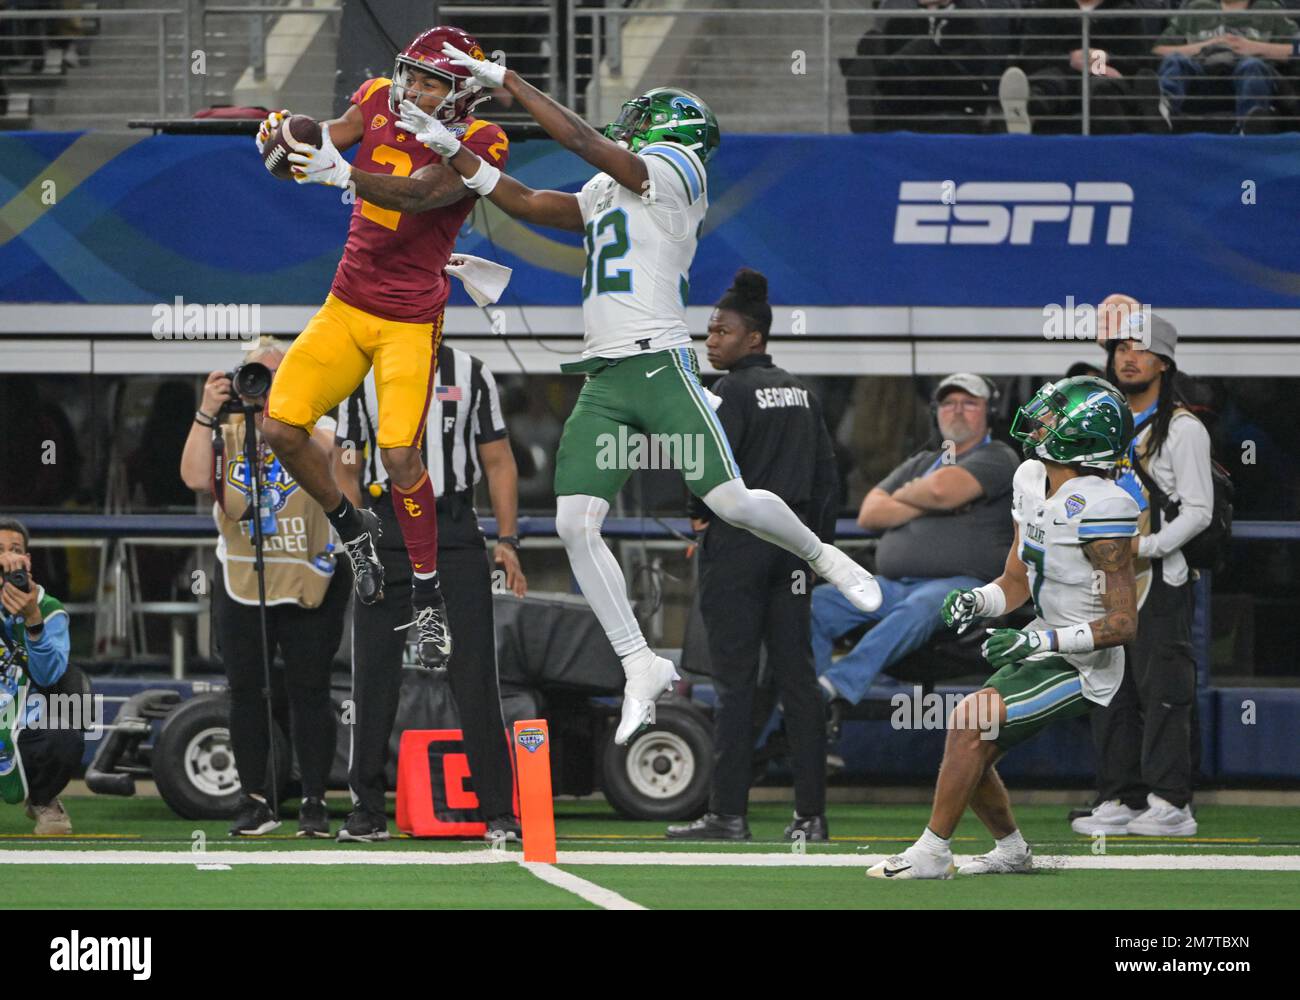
[212,557,352,797]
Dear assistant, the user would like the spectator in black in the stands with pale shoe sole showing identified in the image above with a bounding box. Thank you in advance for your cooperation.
[998,0,1160,135]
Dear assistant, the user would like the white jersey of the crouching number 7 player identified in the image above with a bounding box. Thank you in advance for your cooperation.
[1011,459,1139,705]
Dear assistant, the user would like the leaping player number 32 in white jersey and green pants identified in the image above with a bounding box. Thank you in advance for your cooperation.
[400,46,880,744]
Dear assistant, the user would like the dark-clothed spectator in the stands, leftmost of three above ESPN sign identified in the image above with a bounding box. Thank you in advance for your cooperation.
[858,0,997,131]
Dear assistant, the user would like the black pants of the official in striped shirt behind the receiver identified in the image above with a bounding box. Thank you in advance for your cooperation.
[348,501,515,819]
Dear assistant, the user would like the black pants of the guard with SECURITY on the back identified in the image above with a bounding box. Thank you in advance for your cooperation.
[699,520,826,815]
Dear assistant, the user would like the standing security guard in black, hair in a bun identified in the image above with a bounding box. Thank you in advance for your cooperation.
[668,268,837,840]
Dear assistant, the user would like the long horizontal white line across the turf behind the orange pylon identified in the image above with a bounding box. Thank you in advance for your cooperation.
[0,849,1300,868]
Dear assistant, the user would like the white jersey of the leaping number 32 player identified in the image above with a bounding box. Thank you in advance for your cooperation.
[577,142,709,359]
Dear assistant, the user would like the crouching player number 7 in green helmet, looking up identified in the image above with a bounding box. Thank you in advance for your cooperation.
[867,376,1138,879]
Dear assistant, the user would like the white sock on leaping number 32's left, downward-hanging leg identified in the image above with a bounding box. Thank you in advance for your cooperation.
[555,495,649,657]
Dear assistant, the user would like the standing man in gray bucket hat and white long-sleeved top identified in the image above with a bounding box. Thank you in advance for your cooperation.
[1071,295,1214,836]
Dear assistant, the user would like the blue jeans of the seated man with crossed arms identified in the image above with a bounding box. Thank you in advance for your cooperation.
[813,576,985,705]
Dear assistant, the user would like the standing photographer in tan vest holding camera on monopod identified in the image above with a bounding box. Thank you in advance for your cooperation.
[181,337,352,837]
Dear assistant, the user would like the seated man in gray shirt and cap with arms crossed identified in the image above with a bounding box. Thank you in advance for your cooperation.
[813,373,1021,704]
